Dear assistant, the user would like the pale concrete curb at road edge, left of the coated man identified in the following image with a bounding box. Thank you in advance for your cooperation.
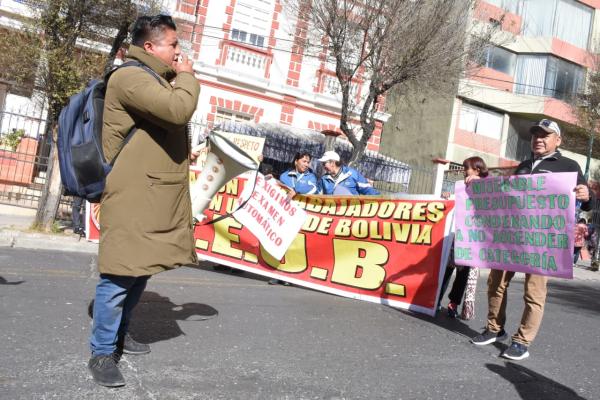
[0,229,98,254]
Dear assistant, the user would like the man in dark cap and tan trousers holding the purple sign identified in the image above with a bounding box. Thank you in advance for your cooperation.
[471,119,593,360]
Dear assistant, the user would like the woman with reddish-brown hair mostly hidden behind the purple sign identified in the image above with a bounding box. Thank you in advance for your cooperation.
[439,157,489,320]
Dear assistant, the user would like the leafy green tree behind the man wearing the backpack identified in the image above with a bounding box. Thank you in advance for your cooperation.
[11,0,157,231]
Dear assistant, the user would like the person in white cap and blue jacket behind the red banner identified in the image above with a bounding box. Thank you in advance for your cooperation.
[319,151,379,195]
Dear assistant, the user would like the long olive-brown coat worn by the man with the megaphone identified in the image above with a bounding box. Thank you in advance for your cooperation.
[99,46,200,276]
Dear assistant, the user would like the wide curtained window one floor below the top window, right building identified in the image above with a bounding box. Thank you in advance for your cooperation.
[515,55,585,100]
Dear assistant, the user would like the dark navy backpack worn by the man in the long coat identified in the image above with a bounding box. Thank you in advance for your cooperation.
[56,61,163,203]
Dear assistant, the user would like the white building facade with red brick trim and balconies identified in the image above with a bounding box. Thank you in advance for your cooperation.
[165,0,387,151]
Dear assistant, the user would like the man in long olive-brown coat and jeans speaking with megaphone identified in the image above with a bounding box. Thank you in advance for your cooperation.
[88,15,200,387]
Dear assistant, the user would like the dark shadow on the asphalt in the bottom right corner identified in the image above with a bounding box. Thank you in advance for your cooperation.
[485,362,585,400]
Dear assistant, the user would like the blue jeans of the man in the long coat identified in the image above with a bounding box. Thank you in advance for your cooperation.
[90,274,150,356]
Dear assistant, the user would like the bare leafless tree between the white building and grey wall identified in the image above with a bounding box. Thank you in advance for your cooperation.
[284,0,493,164]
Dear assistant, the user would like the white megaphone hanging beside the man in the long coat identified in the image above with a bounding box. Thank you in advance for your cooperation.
[190,131,258,221]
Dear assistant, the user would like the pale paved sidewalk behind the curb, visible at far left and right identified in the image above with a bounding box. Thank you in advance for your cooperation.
[0,205,600,281]
